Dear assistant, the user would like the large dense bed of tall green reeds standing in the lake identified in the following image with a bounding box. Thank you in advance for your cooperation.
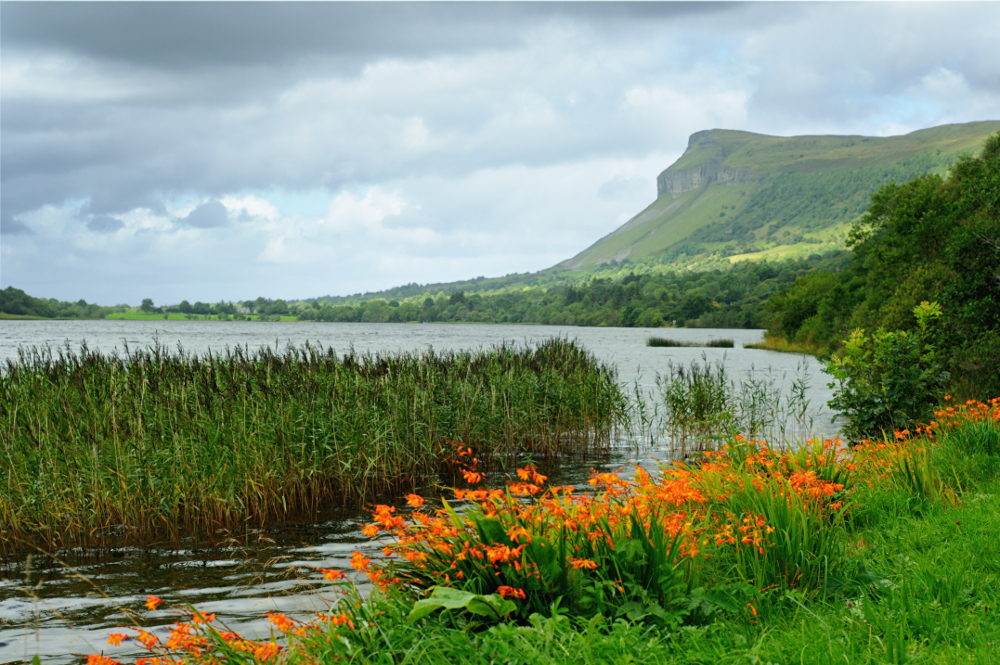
[0,339,628,554]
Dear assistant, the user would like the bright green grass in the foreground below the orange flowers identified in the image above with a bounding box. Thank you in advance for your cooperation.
[292,427,1000,665]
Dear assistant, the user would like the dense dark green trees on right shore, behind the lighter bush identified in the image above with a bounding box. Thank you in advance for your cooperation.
[768,133,1000,396]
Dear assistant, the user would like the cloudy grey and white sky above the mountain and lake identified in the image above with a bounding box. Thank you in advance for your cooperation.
[0,2,1000,305]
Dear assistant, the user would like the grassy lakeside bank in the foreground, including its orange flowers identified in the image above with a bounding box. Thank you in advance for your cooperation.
[107,400,1000,665]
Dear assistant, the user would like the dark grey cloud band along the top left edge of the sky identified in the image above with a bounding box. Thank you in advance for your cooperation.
[0,2,739,68]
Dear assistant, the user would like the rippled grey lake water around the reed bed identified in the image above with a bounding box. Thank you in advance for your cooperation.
[0,321,837,664]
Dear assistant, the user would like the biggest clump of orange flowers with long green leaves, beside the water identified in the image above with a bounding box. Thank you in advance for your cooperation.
[365,441,847,617]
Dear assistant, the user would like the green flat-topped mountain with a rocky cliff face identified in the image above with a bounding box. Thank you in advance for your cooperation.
[557,121,1000,271]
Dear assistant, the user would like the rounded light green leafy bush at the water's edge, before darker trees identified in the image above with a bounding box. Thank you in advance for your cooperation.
[826,302,949,441]
